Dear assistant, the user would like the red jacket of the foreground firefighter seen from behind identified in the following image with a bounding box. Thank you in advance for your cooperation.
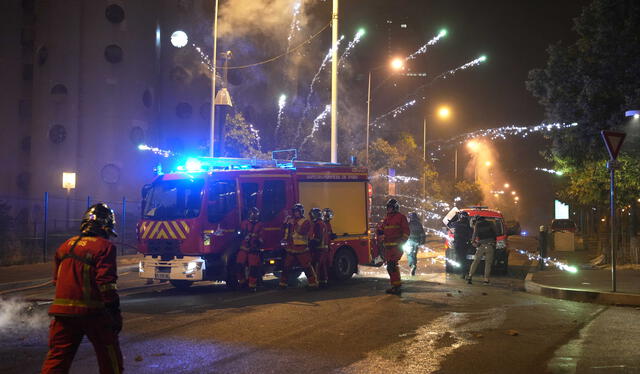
[49,236,120,316]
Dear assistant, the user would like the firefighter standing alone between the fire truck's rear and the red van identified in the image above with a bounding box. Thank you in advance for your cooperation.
[380,199,409,295]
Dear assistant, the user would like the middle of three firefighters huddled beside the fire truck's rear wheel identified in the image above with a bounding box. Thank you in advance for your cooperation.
[309,208,329,288]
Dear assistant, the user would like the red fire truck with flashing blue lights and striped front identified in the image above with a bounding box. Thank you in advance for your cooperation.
[138,158,373,288]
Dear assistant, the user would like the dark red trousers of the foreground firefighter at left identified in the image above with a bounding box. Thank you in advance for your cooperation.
[42,314,123,374]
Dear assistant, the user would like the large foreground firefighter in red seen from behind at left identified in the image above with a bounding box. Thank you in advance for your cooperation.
[42,203,123,373]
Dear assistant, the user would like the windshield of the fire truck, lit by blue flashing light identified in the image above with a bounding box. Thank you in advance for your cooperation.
[143,179,204,220]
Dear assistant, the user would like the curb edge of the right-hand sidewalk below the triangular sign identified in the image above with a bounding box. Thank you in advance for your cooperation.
[524,272,640,306]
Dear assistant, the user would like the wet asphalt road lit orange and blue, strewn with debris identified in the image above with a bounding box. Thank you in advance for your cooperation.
[0,238,640,374]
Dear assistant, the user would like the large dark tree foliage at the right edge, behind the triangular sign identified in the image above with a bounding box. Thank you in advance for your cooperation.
[526,0,640,204]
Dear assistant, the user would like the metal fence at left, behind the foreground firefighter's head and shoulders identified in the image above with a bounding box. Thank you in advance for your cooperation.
[0,192,140,266]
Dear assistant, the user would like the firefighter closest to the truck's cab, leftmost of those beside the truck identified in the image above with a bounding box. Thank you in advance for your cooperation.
[236,207,264,292]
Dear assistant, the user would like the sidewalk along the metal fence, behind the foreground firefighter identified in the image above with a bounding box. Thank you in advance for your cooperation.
[0,254,140,291]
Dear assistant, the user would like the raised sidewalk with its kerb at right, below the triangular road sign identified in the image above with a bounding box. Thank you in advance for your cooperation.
[525,251,640,306]
